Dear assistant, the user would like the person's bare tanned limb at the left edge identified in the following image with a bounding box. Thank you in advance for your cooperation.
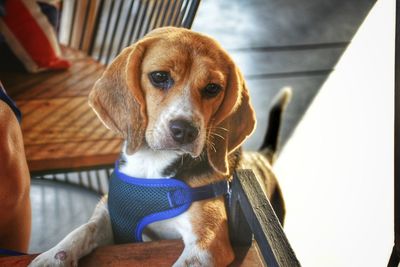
[0,96,31,252]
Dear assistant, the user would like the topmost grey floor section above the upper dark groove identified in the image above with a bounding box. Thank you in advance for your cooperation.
[193,0,376,50]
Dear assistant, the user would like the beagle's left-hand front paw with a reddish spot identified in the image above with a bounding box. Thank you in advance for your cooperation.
[29,248,78,267]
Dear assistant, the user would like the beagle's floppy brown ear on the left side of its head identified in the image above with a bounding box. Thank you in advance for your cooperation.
[89,40,147,154]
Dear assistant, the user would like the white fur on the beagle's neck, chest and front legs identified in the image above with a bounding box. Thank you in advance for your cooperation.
[29,148,212,266]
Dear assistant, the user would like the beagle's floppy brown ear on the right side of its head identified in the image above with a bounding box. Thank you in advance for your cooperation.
[207,66,256,175]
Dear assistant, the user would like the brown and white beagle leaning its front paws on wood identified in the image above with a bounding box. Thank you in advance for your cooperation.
[31,27,290,266]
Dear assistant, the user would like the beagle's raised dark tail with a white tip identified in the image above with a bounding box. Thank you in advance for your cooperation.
[260,87,292,164]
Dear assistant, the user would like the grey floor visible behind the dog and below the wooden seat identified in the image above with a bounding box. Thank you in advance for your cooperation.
[31,0,375,262]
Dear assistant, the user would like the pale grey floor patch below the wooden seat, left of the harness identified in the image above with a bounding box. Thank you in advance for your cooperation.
[29,179,100,253]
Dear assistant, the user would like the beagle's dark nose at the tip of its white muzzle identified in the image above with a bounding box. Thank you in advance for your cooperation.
[169,120,199,145]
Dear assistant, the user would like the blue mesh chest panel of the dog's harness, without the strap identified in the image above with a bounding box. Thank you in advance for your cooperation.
[108,172,190,243]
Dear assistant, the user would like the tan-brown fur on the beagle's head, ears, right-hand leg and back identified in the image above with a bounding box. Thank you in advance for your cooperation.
[89,28,283,266]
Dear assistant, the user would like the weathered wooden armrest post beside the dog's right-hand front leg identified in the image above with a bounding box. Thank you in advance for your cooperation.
[229,170,300,267]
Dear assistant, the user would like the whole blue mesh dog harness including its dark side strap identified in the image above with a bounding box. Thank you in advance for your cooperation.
[108,162,229,243]
